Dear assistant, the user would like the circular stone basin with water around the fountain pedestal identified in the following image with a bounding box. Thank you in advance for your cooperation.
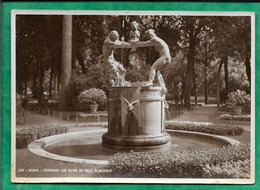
[28,129,239,165]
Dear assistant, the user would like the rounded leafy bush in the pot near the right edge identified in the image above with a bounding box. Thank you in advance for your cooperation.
[228,90,251,106]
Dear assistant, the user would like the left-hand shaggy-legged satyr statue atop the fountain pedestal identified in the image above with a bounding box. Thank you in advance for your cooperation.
[102,30,130,82]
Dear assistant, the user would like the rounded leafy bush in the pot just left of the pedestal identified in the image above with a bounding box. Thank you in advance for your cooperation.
[78,88,107,107]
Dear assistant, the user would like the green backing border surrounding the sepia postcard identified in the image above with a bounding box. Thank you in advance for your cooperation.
[1,2,260,190]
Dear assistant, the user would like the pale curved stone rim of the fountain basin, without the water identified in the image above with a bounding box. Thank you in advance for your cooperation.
[28,129,240,165]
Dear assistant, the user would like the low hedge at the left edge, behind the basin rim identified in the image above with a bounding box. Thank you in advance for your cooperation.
[16,126,68,148]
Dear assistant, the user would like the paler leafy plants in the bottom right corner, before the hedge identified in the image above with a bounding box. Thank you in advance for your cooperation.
[203,159,250,179]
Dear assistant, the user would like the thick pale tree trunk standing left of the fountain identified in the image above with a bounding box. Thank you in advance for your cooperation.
[59,15,72,110]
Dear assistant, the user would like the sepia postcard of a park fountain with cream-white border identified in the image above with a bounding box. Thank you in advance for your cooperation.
[11,10,255,184]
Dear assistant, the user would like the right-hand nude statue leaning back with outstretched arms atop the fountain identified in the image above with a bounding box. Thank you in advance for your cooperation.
[134,29,171,93]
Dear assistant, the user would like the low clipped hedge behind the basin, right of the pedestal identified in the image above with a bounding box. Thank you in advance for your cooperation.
[165,121,244,136]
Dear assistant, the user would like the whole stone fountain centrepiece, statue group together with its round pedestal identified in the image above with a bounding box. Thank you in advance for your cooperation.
[102,22,171,151]
